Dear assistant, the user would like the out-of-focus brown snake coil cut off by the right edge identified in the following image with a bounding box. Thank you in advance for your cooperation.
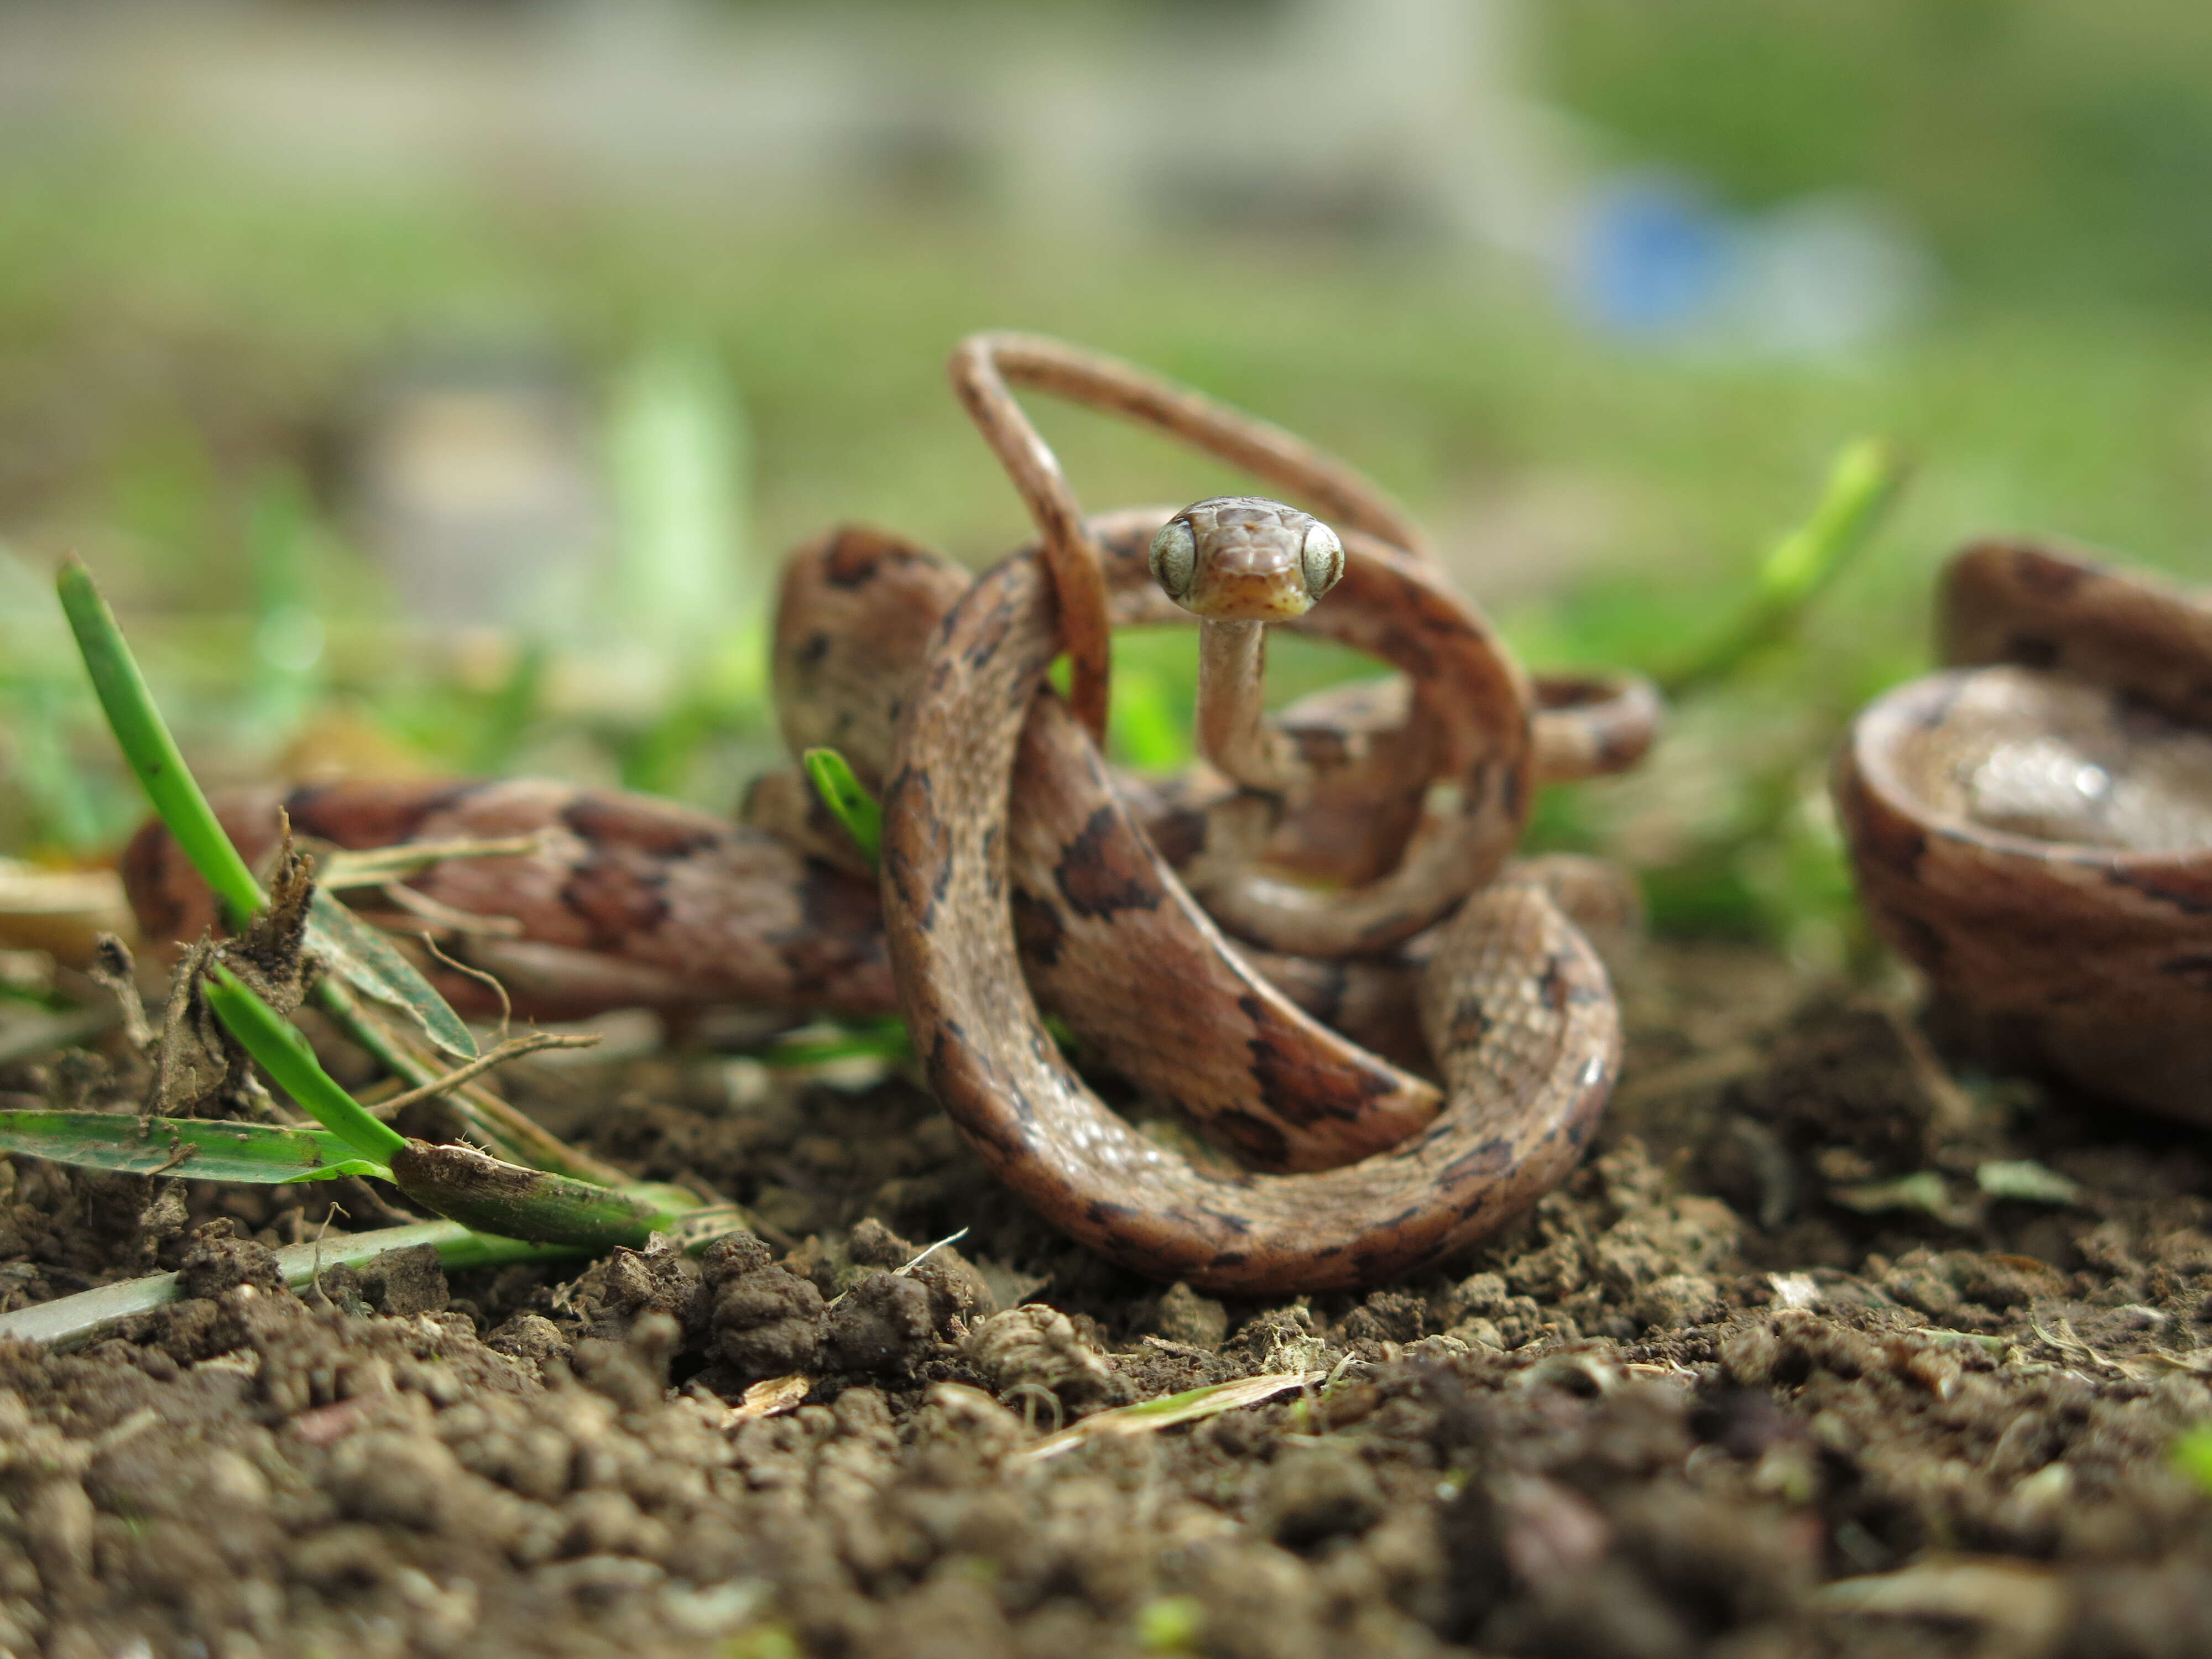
[1832,540,2212,1124]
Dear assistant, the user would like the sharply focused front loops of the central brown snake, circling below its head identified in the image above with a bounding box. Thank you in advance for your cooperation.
[883,341,1619,1292]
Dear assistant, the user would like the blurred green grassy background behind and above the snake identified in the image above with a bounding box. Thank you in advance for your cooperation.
[0,0,2212,964]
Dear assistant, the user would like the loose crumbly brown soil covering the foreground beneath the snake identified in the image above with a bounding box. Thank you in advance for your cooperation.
[0,947,2212,1659]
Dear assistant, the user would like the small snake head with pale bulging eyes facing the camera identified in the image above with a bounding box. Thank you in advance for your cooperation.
[1152,495,1345,622]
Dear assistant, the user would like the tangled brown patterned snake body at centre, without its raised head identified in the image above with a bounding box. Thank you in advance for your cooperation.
[124,336,1655,1292]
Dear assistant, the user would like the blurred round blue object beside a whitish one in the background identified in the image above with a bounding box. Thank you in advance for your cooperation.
[1571,173,1739,334]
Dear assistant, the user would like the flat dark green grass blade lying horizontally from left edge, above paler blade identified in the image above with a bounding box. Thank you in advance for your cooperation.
[0,1113,392,1183]
